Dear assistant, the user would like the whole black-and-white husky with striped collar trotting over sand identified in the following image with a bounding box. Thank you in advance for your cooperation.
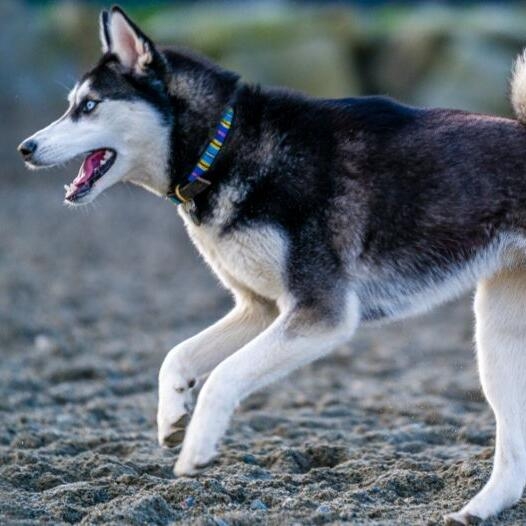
[19,7,526,524]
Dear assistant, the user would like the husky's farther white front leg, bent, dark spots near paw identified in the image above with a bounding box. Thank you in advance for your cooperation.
[157,296,277,446]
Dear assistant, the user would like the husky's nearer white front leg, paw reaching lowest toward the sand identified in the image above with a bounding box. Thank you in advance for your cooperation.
[175,294,359,475]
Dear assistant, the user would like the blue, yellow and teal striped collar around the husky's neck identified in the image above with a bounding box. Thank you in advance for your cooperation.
[167,106,234,208]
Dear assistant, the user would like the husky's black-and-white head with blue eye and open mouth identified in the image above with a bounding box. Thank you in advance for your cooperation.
[18,7,171,204]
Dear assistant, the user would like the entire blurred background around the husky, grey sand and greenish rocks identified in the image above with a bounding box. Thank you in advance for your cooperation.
[0,0,526,526]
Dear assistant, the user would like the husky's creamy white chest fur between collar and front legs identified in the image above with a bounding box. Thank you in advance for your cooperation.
[183,215,285,300]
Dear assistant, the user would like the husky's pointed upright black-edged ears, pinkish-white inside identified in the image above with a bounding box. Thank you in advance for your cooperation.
[99,6,155,73]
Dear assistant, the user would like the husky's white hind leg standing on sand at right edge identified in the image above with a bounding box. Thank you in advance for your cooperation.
[446,269,526,524]
